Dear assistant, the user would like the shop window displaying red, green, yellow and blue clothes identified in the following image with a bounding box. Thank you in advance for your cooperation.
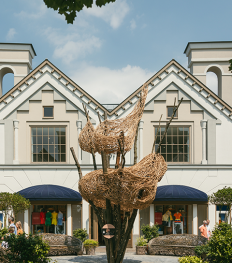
[31,205,67,234]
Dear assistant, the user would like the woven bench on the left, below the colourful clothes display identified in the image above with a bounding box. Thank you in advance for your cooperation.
[41,233,83,256]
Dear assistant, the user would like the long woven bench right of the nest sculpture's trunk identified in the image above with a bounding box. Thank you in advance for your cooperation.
[148,234,207,256]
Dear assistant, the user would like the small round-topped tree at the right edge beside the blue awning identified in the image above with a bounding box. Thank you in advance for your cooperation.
[208,186,232,223]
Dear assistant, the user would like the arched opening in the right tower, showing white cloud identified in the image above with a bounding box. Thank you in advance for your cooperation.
[206,66,222,98]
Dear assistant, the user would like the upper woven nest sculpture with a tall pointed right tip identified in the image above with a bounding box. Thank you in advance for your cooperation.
[78,85,148,154]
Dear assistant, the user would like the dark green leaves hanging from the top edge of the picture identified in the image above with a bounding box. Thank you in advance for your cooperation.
[44,0,116,24]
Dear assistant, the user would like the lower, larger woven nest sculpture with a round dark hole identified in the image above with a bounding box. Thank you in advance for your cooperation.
[79,153,167,211]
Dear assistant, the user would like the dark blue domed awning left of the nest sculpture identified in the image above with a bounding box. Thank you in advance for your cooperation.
[18,184,82,202]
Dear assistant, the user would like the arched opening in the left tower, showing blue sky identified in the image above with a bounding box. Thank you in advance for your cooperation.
[0,67,14,97]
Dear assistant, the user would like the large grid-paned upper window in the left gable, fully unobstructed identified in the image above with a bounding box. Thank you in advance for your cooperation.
[31,127,66,163]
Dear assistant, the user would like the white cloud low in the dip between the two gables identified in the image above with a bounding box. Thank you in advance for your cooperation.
[70,65,155,104]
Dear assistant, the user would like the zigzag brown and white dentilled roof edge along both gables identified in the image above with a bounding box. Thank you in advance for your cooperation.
[0,59,232,119]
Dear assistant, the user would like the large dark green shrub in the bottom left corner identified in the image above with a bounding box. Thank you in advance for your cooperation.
[4,233,50,263]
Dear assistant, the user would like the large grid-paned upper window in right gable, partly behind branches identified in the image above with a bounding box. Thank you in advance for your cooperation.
[155,126,190,163]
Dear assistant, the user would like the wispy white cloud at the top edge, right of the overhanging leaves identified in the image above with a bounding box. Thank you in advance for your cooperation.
[83,0,130,29]
